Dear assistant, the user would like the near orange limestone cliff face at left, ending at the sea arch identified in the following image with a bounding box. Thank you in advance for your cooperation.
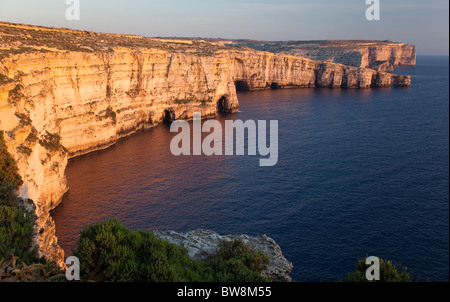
[0,50,238,264]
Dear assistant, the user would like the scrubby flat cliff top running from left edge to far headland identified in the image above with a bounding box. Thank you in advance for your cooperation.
[0,22,414,60]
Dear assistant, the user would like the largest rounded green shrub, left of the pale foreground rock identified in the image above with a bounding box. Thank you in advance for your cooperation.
[75,220,208,282]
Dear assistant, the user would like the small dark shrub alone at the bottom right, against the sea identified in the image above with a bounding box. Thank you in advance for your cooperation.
[346,257,411,282]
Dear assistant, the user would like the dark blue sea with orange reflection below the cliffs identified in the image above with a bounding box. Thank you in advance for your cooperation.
[53,57,449,281]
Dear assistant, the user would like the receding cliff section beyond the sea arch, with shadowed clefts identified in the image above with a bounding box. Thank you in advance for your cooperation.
[229,51,397,90]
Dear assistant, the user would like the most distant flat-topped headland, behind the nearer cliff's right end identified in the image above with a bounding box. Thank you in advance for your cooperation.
[229,40,416,72]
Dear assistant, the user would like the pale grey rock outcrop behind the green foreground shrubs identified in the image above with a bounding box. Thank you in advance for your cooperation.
[153,230,293,282]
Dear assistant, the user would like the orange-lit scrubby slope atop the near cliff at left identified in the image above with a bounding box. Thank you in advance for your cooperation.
[0,22,230,58]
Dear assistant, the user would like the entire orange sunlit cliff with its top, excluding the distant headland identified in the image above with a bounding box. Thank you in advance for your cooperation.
[0,23,410,265]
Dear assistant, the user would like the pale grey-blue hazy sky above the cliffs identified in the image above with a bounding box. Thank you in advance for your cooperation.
[0,0,449,55]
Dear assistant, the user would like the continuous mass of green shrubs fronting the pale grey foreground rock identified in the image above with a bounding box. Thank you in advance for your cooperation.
[74,220,268,282]
